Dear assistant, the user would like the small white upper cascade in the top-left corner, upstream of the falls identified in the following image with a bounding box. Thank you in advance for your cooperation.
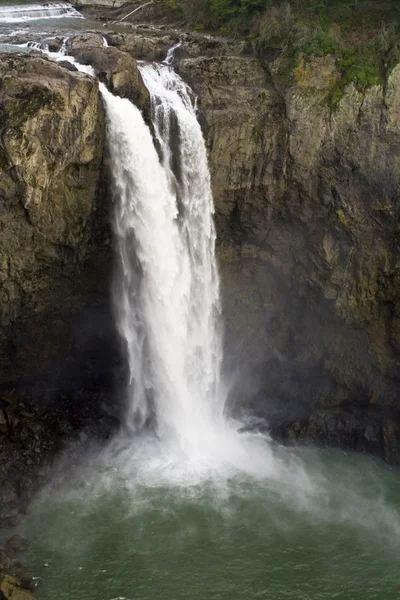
[0,2,83,23]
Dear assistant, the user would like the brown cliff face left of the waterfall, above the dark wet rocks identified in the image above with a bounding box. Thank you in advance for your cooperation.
[0,55,112,390]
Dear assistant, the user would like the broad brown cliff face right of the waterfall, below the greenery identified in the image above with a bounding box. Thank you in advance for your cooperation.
[180,57,400,460]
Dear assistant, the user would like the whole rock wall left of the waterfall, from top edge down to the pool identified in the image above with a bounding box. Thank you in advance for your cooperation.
[0,54,118,528]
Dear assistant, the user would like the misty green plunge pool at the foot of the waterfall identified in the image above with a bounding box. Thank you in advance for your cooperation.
[24,448,400,600]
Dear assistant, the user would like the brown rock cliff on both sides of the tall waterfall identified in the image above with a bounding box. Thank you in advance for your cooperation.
[0,32,400,461]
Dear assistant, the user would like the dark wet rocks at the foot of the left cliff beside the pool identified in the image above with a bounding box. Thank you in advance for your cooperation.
[0,390,120,528]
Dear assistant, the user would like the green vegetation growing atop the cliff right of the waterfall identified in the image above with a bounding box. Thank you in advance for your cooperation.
[158,0,400,91]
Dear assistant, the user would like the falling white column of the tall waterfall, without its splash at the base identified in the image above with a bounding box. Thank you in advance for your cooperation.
[101,66,223,454]
